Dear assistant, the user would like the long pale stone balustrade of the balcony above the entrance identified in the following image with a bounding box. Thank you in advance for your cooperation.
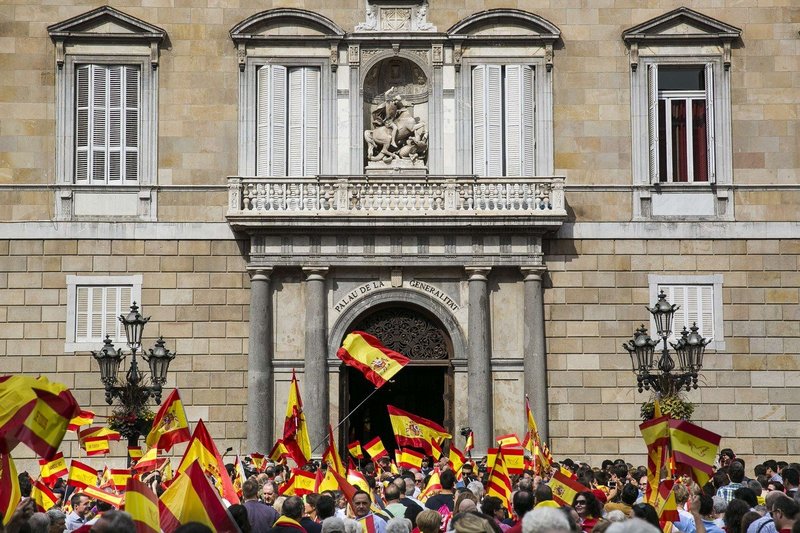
[227,176,566,218]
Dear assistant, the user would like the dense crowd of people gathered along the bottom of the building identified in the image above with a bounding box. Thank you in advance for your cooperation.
[6,449,800,533]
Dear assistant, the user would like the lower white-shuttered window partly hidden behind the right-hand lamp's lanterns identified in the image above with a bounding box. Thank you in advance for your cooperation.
[649,275,725,350]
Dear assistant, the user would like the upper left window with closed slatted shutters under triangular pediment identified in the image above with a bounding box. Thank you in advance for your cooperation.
[75,65,141,184]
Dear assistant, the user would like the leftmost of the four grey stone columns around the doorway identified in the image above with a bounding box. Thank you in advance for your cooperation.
[247,268,275,453]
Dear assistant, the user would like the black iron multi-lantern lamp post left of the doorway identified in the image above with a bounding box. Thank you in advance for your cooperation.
[92,302,175,456]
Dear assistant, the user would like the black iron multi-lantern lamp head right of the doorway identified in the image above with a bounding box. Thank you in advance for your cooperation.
[622,291,711,396]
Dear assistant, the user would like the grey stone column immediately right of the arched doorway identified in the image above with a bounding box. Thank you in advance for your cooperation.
[466,267,494,456]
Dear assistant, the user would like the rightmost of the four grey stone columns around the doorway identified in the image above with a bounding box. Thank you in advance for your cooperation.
[520,267,549,442]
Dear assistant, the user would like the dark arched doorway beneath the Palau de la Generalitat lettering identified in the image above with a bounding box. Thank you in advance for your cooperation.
[341,303,453,453]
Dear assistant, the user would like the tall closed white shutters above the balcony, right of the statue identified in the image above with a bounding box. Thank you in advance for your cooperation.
[472,65,535,176]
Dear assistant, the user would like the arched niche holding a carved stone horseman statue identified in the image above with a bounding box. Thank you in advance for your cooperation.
[364,57,428,175]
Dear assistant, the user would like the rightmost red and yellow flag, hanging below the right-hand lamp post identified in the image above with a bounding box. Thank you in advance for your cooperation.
[669,419,721,487]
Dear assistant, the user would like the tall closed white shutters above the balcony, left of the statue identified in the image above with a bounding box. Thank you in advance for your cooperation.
[256,65,320,176]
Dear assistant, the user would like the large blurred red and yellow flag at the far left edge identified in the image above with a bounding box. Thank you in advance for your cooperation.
[0,375,80,459]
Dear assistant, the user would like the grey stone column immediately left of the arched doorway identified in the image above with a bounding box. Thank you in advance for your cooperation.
[300,267,329,448]
